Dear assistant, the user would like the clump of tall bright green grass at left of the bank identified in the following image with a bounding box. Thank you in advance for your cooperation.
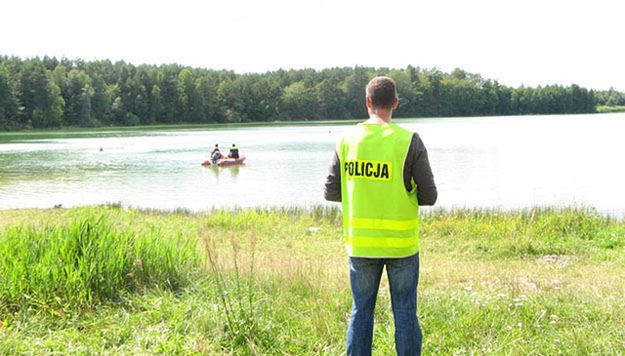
[0,214,199,313]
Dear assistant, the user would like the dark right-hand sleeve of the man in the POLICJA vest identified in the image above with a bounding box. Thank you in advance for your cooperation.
[404,133,438,205]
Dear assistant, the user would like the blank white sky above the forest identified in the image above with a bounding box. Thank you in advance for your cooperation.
[0,0,625,91]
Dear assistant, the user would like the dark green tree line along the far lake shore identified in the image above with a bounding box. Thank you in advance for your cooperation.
[0,56,625,130]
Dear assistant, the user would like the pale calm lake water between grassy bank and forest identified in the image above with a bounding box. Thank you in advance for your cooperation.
[0,113,625,214]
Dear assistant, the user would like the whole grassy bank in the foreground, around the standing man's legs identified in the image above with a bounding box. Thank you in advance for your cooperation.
[0,207,625,355]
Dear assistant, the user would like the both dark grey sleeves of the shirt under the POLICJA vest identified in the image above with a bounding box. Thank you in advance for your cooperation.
[324,133,438,205]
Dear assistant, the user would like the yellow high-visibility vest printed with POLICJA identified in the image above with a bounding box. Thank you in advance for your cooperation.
[337,123,419,258]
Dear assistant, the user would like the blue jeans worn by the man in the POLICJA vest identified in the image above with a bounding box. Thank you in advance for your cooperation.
[347,253,422,356]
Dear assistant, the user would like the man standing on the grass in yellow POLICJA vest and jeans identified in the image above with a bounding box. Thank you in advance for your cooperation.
[324,77,438,355]
